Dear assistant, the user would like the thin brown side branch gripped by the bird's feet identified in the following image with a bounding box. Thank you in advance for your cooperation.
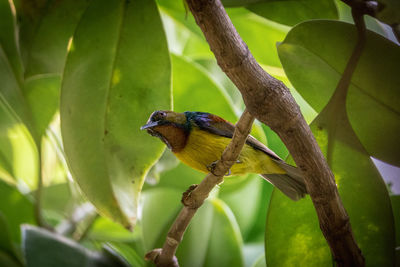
[145,109,254,267]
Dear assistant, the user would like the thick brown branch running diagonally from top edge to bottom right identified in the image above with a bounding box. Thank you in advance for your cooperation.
[187,0,364,266]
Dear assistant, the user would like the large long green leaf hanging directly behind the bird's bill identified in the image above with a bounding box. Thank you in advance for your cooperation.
[60,0,171,226]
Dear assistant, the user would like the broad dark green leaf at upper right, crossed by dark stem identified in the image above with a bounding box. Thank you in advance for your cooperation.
[278,21,400,165]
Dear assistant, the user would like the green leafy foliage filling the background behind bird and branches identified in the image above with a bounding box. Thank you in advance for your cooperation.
[0,0,400,267]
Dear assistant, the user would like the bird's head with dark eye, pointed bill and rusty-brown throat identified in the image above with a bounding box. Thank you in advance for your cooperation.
[140,110,190,152]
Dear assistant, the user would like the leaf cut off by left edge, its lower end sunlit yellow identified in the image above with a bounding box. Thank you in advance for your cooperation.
[0,42,37,186]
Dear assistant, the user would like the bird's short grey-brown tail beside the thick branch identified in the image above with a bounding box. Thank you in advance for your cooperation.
[261,161,307,201]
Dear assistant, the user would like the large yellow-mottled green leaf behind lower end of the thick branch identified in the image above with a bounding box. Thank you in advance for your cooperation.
[265,81,395,266]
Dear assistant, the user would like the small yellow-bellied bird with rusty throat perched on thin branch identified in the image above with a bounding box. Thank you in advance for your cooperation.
[141,110,307,200]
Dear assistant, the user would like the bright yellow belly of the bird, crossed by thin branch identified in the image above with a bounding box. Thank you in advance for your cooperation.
[174,129,286,175]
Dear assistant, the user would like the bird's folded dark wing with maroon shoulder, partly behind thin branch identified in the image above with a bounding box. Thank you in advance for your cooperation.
[192,112,282,161]
